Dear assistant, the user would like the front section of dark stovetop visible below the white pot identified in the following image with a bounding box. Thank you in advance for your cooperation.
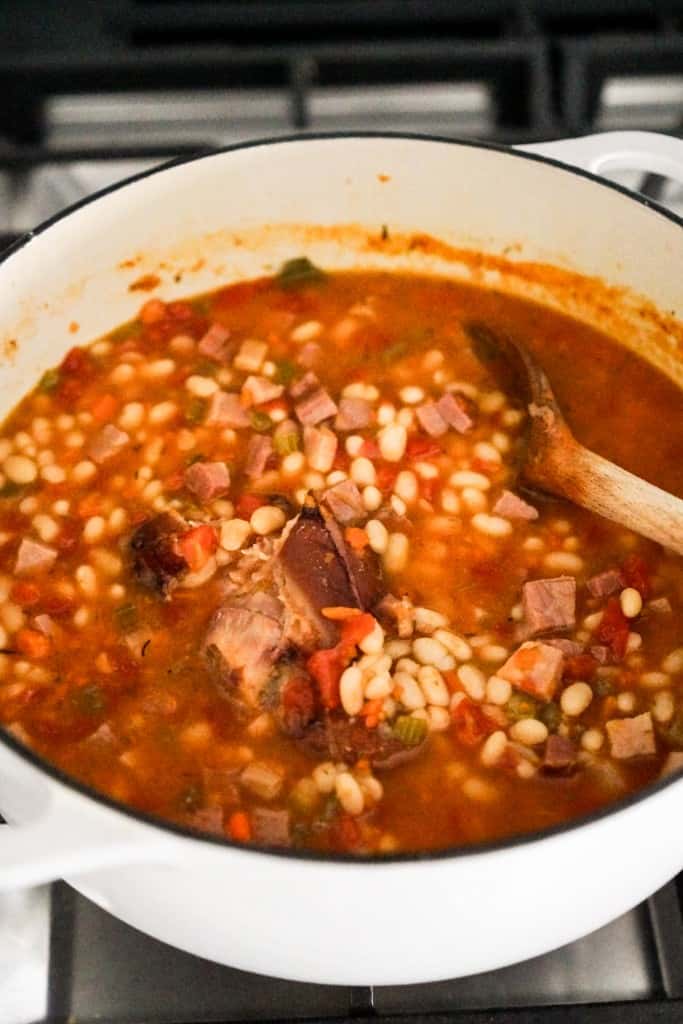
[38,879,683,1024]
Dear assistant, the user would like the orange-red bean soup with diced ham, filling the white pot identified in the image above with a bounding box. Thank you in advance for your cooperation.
[0,258,683,854]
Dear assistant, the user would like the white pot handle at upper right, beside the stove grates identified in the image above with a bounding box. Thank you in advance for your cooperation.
[517,131,683,184]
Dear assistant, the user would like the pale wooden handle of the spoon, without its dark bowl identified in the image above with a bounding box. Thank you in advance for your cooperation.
[546,442,683,555]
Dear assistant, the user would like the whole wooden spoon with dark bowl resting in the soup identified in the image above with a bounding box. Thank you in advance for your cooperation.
[468,324,683,555]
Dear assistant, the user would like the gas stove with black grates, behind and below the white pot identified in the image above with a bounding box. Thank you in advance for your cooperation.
[0,0,683,1024]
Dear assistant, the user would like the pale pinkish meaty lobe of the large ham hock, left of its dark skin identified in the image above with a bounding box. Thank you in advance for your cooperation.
[204,599,285,707]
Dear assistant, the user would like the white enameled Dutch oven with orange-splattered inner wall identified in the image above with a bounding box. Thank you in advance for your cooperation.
[0,133,683,985]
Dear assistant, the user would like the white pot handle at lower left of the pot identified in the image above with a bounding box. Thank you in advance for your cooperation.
[0,799,179,891]
